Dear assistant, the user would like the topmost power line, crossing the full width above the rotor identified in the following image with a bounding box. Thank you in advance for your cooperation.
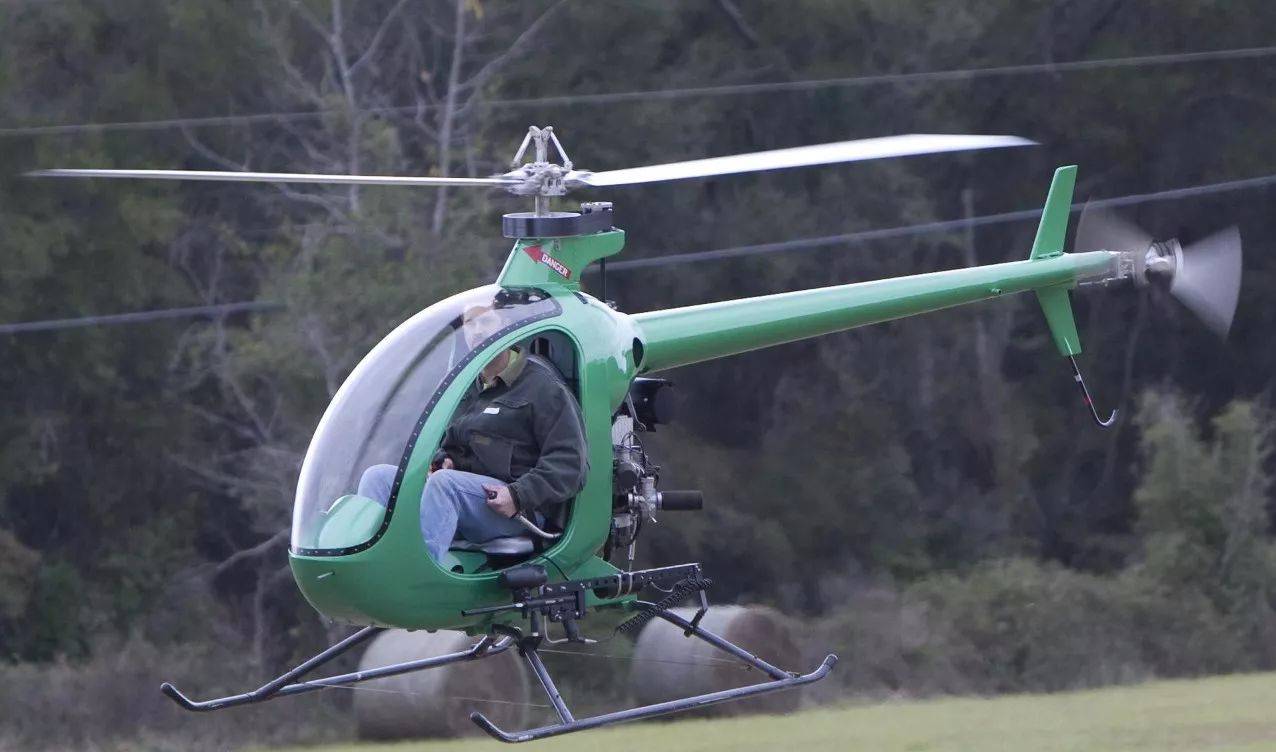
[0,46,1276,137]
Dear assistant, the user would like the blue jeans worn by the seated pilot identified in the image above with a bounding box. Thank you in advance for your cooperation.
[357,465,527,562]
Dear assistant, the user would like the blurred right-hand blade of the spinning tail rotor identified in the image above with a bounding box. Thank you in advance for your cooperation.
[1170,225,1240,337]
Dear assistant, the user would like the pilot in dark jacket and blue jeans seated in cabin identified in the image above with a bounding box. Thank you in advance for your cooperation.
[359,300,590,562]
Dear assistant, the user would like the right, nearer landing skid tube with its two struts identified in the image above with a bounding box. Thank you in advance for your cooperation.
[470,601,837,744]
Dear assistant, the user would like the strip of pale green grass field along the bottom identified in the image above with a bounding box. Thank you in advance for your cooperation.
[271,674,1276,752]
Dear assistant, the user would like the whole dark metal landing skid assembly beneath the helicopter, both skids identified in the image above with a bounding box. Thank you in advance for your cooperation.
[161,564,837,743]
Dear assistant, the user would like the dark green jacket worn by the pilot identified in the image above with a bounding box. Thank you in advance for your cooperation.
[438,354,590,518]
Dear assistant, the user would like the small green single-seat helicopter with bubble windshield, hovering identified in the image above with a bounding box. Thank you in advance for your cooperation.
[31,126,1240,742]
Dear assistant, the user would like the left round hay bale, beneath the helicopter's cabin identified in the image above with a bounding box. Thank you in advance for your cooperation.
[355,629,528,739]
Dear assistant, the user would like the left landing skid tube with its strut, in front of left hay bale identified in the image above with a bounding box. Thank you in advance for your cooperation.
[160,627,514,712]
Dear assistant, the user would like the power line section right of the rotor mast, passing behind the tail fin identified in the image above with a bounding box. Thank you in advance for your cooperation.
[607,175,1276,271]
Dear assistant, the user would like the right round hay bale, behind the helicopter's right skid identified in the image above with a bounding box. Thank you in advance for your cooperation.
[632,605,801,715]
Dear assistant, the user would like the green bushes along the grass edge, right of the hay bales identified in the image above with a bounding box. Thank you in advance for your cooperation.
[820,389,1276,692]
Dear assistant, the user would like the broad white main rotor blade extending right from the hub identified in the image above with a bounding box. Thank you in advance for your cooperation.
[568,133,1036,186]
